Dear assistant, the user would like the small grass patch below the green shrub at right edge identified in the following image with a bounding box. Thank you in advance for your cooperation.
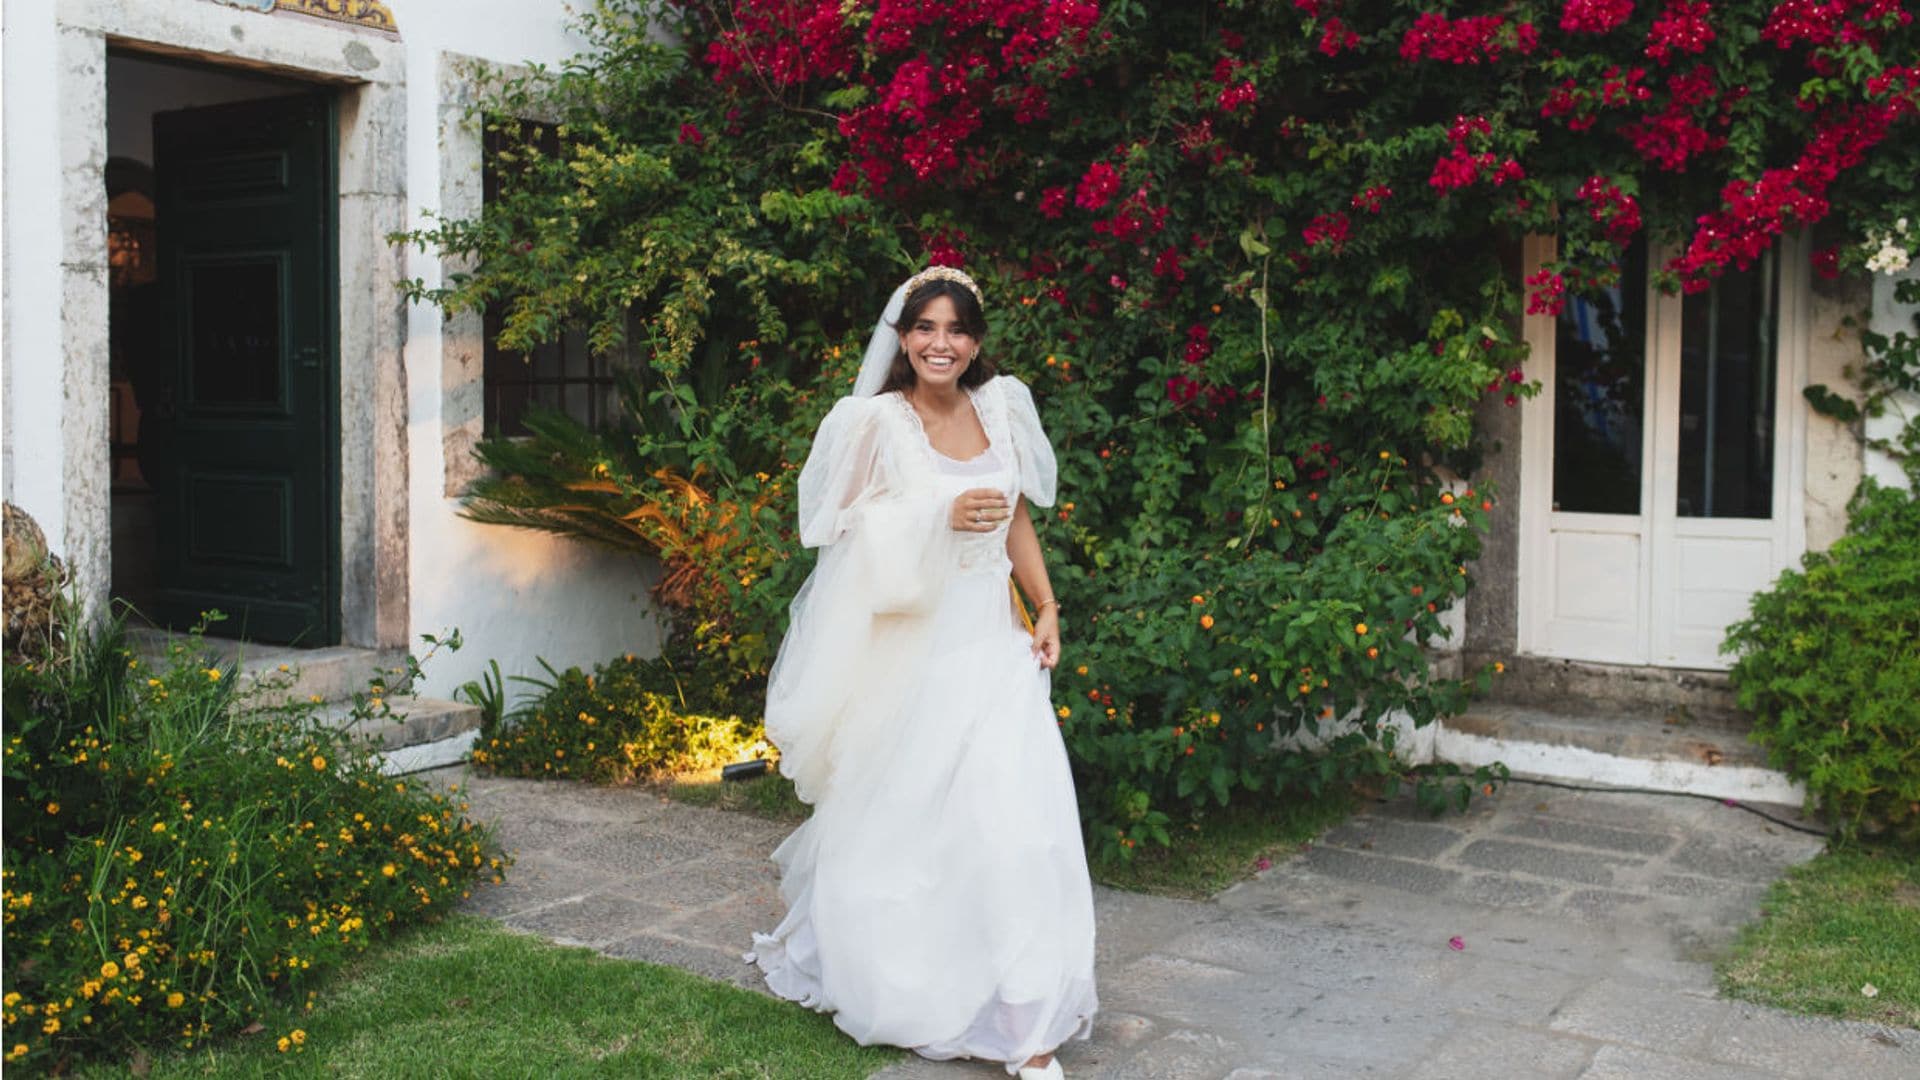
[1718,849,1920,1028]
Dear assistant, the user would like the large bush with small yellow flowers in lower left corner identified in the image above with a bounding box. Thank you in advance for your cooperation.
[0,621,501,1068]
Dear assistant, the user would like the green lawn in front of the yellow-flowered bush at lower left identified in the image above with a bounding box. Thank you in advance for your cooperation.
[77,917,899,1080]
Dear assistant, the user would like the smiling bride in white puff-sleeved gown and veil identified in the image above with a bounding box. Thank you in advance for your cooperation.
[747,267,1098,1080]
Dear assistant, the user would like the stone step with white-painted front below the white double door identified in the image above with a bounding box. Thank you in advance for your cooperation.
[1421,701,1807,803]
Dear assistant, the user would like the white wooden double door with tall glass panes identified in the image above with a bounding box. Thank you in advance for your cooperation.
[1519,238,1805,669]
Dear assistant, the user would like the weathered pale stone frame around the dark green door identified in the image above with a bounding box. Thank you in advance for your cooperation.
[54,0,409,648]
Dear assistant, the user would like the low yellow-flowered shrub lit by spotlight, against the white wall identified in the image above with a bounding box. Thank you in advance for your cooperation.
[472,653,764,784]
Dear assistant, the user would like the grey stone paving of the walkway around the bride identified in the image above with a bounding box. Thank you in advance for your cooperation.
[453,764,1920,1080]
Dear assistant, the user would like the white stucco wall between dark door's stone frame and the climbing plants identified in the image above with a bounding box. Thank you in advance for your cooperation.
[392,0,659,696]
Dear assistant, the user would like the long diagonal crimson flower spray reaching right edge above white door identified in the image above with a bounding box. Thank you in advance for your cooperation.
[1667,97,1914,292]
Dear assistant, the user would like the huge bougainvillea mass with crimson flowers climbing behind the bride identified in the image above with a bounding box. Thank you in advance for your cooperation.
[397,0,1920,853]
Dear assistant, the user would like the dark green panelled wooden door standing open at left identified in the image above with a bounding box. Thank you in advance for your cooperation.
[142,94,340,646]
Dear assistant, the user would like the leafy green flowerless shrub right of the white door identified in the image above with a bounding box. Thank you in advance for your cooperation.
[1722,480,1920,846]
